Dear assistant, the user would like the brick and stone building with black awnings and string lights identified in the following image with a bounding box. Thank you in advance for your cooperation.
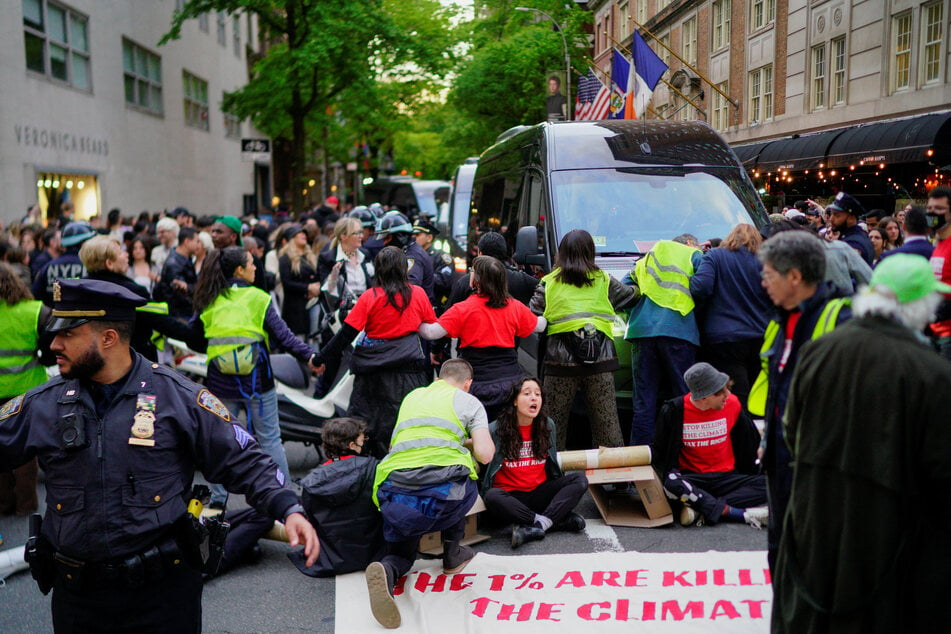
[588,0,951,205]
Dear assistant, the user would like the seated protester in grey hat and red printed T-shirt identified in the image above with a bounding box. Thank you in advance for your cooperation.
[653,363,769,528]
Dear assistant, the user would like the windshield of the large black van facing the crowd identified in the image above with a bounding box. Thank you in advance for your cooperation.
[551,166,765,254]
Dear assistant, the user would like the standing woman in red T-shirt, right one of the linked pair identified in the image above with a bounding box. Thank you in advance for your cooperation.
[419,255,547,419]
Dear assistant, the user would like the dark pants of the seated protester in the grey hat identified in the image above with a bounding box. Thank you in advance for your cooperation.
[664,469,772,525]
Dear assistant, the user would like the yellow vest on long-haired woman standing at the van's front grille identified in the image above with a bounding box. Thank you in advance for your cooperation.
[542,269,614,339]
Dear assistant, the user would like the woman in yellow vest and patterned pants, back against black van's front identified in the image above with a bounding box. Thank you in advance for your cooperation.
[529,229,638,450]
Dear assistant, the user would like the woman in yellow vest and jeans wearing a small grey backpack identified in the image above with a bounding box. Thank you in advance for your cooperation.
[189,247,314,503]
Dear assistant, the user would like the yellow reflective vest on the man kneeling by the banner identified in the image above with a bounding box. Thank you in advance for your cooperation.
[373,381,478,506]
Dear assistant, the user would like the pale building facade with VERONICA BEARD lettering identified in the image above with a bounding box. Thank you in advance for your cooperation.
[0,0,270,222]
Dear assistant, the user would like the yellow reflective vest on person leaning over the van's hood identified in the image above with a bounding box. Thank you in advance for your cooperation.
[634,240,697,315]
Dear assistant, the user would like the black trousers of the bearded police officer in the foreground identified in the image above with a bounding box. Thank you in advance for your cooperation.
[52,566,202,634]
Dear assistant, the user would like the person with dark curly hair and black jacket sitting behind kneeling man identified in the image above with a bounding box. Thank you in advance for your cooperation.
[287,418,383,577]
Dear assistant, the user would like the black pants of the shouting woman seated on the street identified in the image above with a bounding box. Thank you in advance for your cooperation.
[482,471,588,526]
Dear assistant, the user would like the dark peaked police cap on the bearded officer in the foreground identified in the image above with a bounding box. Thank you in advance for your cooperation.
[46,279,147,332]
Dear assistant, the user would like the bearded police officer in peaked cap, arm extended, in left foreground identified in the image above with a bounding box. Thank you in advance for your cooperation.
[0,280,319,632]
